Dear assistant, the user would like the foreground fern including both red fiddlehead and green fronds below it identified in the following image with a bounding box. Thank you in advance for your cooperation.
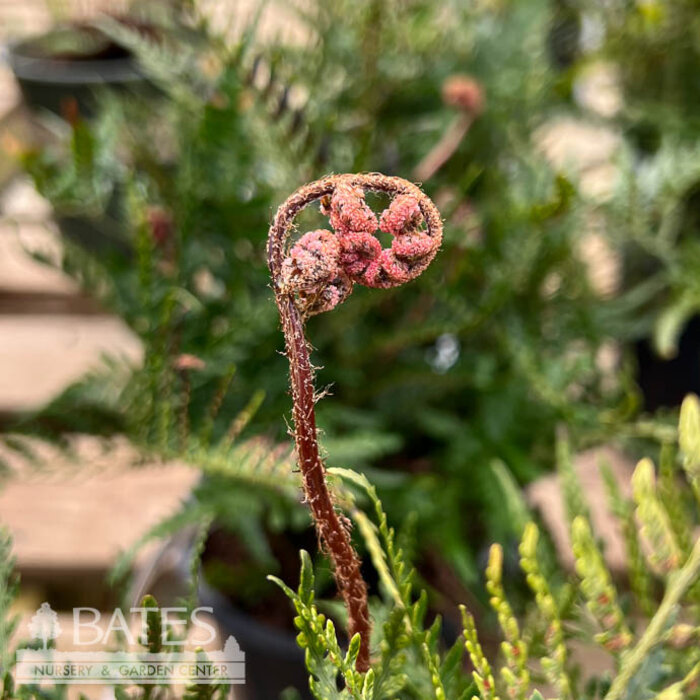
[268,174,700,700]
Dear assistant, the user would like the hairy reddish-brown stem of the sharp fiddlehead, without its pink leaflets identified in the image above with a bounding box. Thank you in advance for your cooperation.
[267,173,442,672]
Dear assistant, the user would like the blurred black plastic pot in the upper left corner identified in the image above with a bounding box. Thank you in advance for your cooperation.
[8,29,146,115]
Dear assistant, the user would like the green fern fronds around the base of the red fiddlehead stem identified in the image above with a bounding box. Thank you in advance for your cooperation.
[270,469,471,700]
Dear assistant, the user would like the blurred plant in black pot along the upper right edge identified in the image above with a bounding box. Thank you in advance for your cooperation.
[581,0,700,410]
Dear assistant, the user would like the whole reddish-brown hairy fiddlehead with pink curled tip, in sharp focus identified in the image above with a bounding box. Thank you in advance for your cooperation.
[267,173,442,671]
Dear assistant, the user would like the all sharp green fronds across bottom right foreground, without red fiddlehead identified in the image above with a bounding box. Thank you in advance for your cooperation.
[273,395,700,700]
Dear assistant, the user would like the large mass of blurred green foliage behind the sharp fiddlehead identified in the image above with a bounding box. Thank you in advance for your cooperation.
[10,0,688,596]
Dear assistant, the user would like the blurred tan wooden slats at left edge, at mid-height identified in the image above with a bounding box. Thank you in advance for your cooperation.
[0,180,142,413]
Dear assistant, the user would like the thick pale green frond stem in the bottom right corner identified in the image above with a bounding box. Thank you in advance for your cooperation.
[605,539,700,700]
